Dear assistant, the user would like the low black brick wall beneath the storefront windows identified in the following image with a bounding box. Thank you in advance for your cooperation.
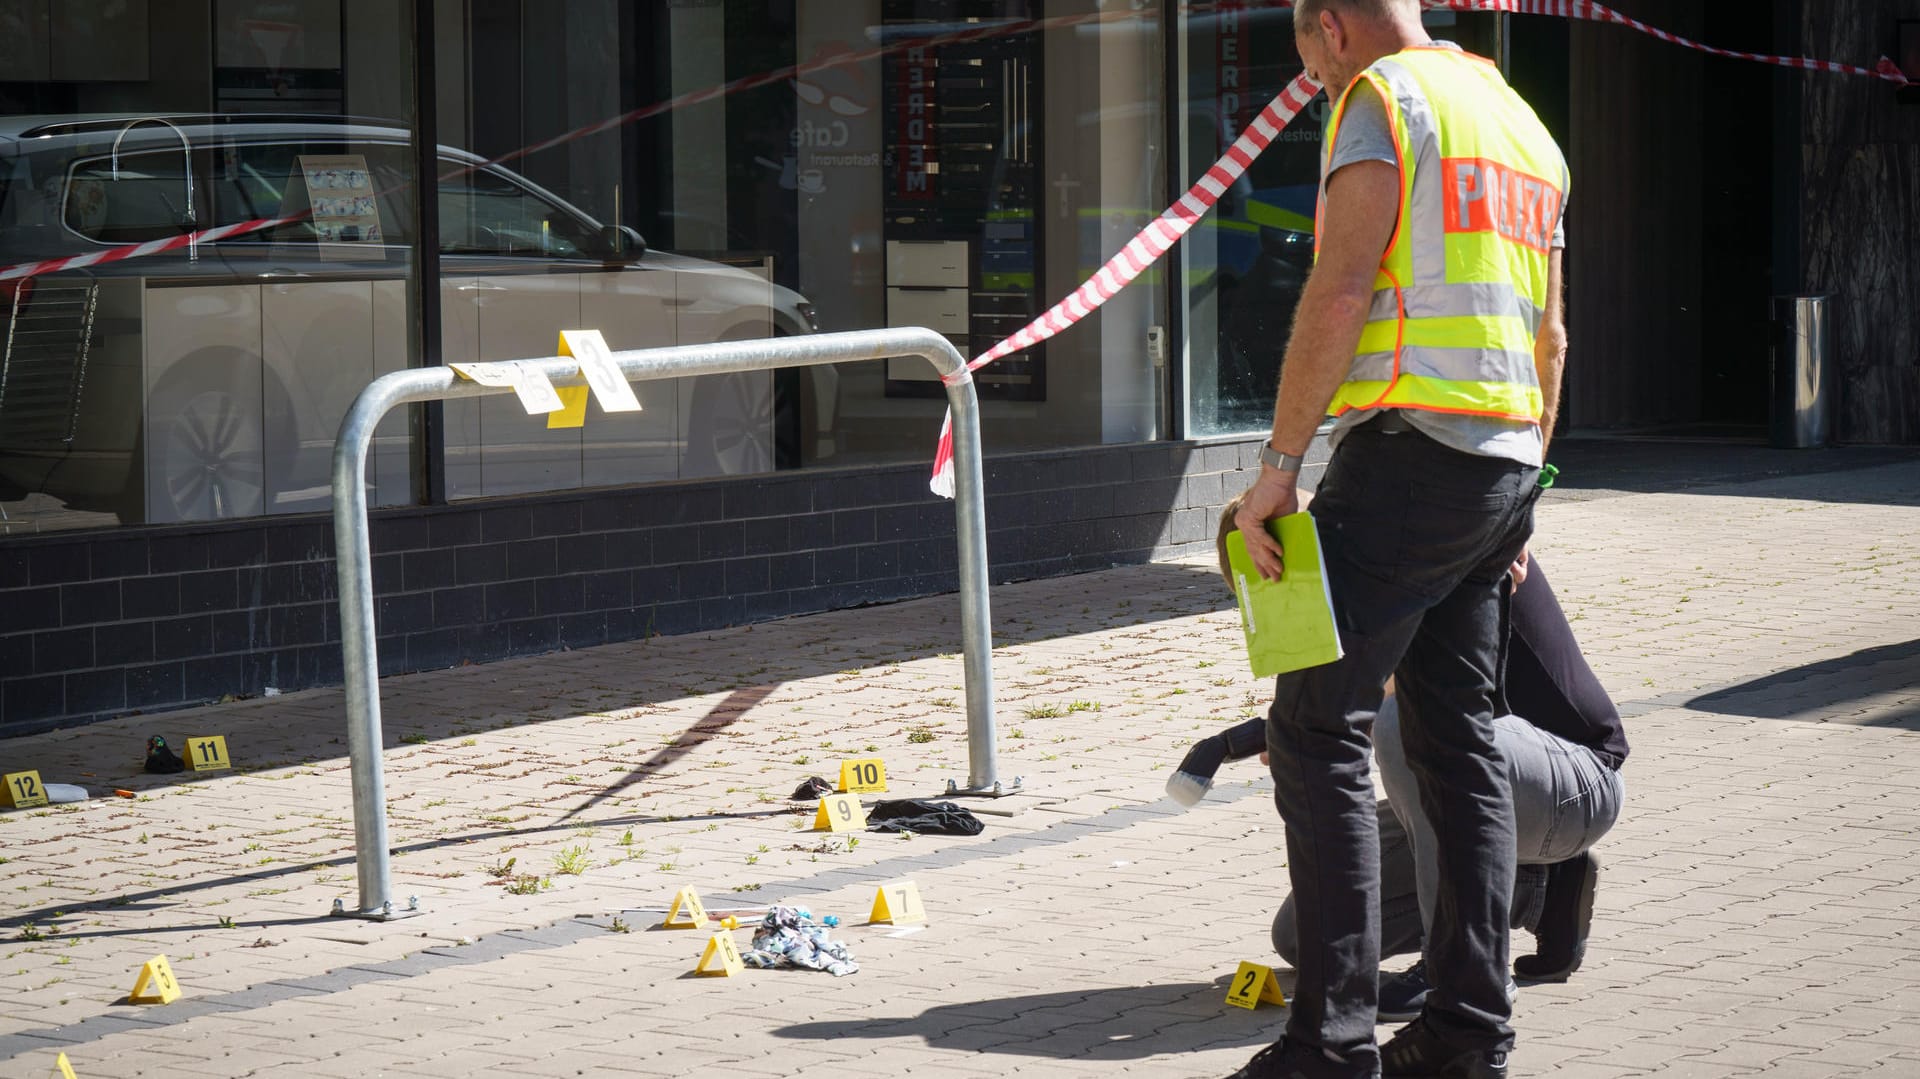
[0,433,1290,735]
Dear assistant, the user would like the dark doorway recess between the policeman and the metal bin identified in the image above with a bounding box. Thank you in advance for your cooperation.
[1559,0,1797,440]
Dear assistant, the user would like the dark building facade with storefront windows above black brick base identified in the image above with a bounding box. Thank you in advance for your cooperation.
[0,0,1920,733]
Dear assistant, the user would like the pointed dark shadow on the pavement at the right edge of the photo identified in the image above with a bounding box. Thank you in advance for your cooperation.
[1686,639,1920,731]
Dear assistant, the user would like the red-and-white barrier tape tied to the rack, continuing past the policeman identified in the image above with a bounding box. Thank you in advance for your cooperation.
[927,0,1912,499]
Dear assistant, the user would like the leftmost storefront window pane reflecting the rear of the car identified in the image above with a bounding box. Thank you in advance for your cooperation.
[0,0,413,534]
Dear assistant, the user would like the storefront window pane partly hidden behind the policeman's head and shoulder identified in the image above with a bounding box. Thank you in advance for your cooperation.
[1175,8,1501,438]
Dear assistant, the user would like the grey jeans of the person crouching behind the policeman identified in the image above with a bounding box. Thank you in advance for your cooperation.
[1273,697,1624,964]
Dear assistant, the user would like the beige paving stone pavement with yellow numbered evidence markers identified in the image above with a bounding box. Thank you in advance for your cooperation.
[0,461,1920,1079]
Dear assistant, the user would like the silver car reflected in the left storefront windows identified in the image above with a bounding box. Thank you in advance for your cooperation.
[0,117,814,522]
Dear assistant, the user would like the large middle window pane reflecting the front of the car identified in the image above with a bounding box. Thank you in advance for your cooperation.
[442,0,1167,495]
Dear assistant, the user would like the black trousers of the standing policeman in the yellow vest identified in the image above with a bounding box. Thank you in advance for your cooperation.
[1267,422,1538,1075]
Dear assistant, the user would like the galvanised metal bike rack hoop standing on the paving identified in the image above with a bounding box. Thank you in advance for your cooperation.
[334,328,1018,920]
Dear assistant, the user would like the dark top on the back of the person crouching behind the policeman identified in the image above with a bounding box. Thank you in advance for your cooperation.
[1501,557,1626,772]
